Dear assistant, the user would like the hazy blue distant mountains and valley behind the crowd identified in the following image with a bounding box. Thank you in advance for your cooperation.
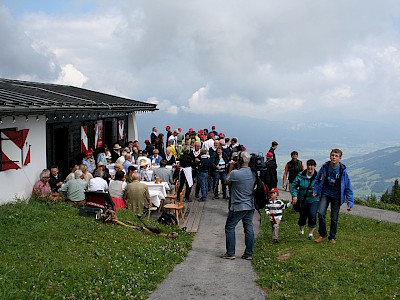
[138,112,400,197]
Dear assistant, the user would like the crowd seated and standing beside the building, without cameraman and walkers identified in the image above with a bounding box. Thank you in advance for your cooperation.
[33,126,244,212]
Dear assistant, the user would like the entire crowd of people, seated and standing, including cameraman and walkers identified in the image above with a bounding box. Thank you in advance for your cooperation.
[33,125,353,260]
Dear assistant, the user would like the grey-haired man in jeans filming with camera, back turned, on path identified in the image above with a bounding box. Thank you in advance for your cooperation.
[222,151,256,260]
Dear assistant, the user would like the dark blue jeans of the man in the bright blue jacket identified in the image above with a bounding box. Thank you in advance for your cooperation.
[318,196,340,240]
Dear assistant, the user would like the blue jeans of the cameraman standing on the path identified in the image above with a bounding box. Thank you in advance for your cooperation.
[225,209,254,257]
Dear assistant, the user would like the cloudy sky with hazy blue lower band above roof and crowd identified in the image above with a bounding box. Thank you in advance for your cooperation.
[0,0,400,155]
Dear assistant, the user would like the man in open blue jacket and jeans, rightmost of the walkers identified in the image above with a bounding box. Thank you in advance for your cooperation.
[313,149,354,244]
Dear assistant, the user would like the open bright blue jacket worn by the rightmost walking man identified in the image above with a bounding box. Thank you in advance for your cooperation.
[314,161,354,208]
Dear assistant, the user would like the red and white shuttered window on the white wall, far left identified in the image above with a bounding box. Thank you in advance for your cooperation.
[1,129,31,171]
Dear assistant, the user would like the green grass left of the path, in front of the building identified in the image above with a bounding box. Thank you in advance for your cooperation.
[0,202,193,299]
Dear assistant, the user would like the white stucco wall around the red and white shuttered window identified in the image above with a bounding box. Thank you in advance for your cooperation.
[0,115,46,205]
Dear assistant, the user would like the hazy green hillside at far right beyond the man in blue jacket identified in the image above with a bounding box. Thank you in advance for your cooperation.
[345,147,400,197]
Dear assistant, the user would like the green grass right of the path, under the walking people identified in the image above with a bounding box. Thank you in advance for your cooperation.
[253,211,400,300]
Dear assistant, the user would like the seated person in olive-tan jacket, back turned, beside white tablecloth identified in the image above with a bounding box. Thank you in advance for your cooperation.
[125,173,151,216]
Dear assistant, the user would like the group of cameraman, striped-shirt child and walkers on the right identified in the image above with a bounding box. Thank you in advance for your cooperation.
[221,147,354,260]
